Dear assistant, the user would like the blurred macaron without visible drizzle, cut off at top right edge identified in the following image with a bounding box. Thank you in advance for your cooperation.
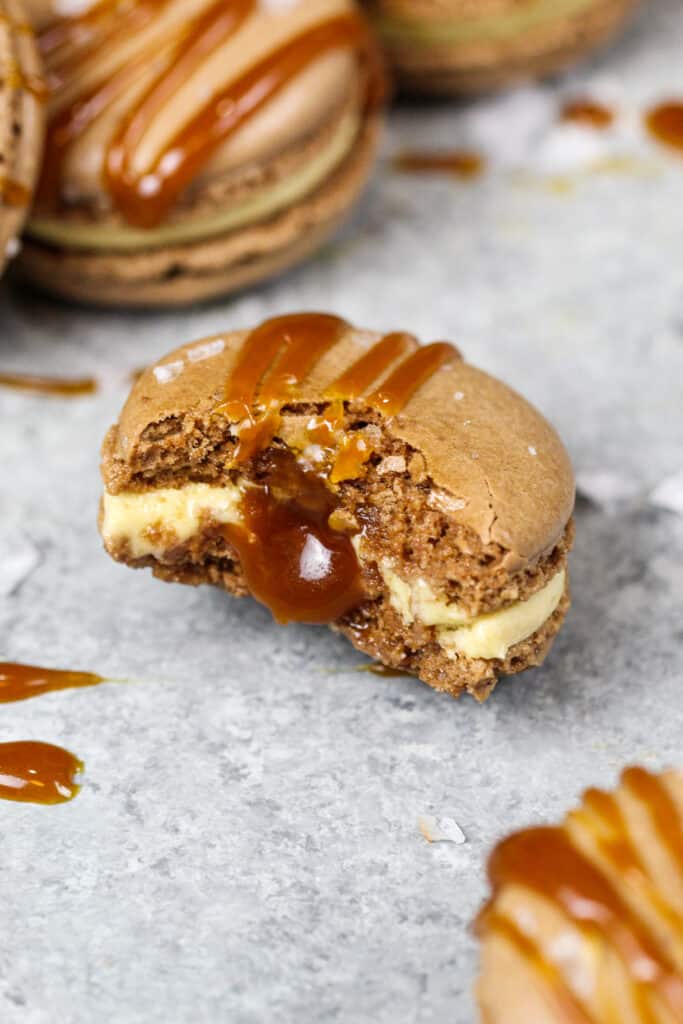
[367,0,637,95]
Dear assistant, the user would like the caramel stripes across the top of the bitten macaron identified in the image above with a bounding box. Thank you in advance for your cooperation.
[215,313,462,468]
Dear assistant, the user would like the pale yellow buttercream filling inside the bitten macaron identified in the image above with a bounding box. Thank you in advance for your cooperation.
[101,483,566,660]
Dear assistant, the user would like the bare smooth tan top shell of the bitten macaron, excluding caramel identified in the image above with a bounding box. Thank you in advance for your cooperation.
[108,325,574,571]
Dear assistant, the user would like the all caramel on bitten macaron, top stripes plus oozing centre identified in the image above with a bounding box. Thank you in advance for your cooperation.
[215,313,459,623]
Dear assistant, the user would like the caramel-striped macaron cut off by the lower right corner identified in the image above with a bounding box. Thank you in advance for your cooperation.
[477,768,683,1024]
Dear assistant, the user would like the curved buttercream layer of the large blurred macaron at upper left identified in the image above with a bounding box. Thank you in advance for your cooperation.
[27,112,360,252]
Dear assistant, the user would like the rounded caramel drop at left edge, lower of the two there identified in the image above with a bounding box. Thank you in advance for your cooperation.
[0,740,83,805]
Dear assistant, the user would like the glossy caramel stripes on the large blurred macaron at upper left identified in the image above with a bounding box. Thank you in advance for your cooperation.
[39,0,377,229]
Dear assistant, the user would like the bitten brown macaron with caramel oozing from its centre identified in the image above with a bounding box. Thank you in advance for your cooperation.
[100,313,573,700]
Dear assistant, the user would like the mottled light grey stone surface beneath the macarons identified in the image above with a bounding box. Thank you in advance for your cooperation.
[0,0,683,1024]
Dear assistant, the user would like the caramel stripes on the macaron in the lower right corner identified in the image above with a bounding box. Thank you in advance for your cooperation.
[477,768,683,1024]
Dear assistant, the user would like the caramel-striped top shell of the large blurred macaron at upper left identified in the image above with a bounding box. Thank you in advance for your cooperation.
[30,0,376,229]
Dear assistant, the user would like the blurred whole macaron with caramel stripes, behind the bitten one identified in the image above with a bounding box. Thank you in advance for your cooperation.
[17,0,382,306]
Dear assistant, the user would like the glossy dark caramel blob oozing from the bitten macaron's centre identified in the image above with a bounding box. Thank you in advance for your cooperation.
[223,451,364,624]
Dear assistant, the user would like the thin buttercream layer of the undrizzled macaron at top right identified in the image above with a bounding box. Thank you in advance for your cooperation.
[377,0,595,46]
